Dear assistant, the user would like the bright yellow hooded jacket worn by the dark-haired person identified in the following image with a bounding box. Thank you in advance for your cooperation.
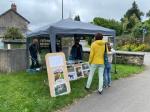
[89,40,106,64]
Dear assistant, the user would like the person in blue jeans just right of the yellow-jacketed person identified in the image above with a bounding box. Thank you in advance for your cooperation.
[103,43,115,88]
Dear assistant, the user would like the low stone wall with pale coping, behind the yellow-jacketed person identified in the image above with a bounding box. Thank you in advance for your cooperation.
[83,51,144,65]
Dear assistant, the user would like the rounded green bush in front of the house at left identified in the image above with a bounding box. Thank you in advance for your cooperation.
[4,27,23,39]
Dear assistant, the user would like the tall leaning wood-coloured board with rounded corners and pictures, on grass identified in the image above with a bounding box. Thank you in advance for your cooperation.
[45,53,71,97]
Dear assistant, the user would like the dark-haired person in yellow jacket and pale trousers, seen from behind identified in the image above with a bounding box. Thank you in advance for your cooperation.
[85,33,106,94]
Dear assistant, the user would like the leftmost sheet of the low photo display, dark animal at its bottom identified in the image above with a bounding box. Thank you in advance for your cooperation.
[67,65,77,80]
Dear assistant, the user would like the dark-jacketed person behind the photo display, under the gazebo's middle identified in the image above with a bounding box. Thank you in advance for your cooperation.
[70,39,83,60]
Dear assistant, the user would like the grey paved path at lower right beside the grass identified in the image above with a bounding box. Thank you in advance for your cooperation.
[65,53,150,112]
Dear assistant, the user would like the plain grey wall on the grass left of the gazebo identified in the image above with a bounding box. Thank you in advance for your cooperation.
[0,49,26,72]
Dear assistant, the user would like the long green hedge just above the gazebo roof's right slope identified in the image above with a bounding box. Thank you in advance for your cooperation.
[93,17,122,35]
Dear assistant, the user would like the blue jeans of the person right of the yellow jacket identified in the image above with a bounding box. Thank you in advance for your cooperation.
[104,63,111,87]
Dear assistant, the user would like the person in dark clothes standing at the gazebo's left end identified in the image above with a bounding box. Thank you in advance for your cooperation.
[29,39,40,69]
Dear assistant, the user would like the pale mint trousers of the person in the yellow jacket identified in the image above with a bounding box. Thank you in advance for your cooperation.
[86,64,104,91]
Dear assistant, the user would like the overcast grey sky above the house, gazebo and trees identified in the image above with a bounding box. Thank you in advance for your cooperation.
[0,0,150,30]
